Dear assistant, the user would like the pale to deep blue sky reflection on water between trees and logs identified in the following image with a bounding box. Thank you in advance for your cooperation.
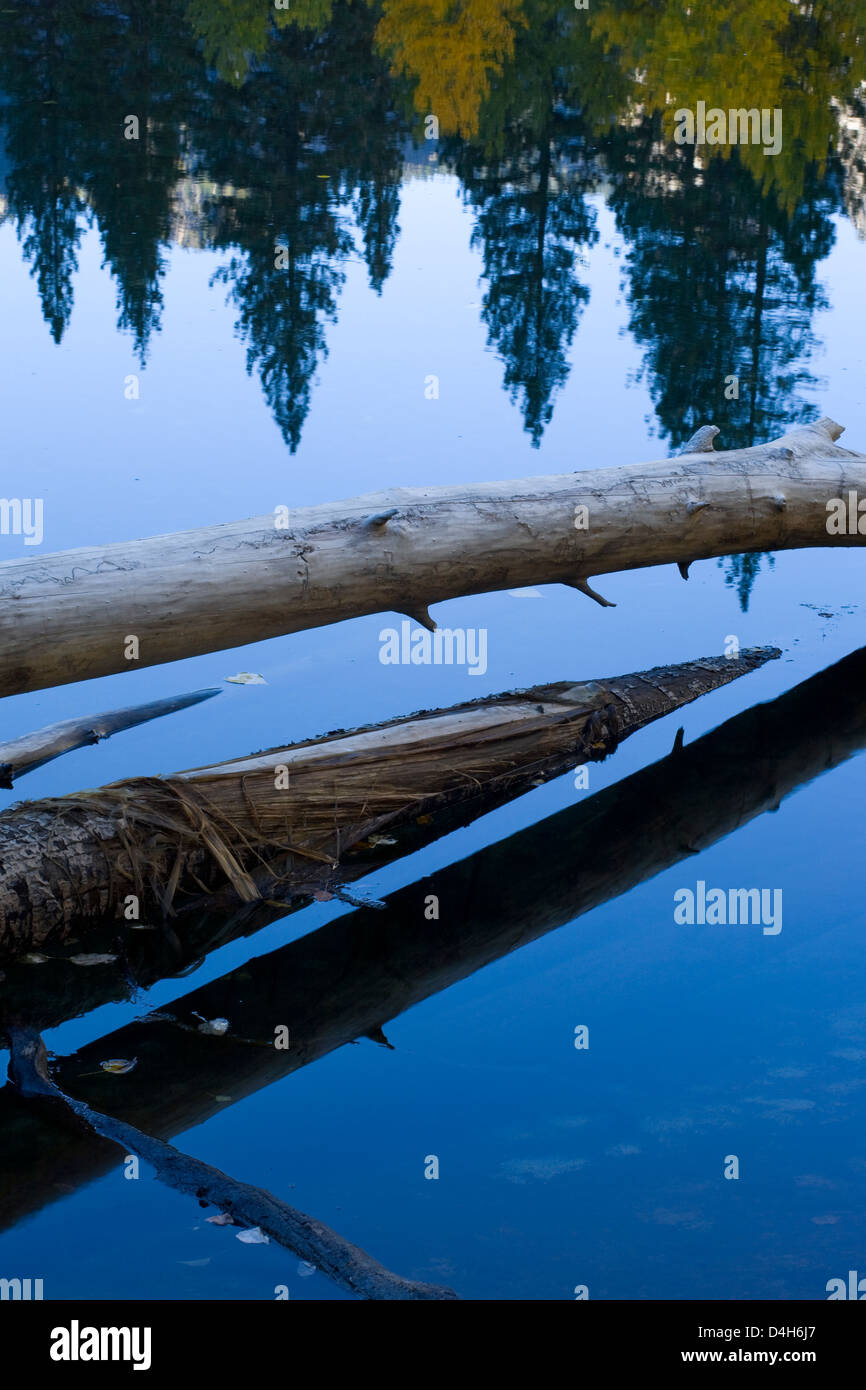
[0,177,866,1298]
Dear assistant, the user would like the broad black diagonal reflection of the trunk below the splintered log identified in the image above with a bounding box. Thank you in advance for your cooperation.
[0,639,866,1230]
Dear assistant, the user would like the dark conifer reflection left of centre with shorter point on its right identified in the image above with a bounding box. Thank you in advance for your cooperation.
[200,4,402,452]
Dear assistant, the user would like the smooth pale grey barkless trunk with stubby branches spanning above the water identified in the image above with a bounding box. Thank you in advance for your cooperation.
[0,420,866,695]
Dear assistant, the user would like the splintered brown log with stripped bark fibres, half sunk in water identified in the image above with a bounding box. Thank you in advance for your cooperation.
[0,648,780,955]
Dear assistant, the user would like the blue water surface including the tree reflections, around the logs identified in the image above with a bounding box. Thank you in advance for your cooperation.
[0,0,866,1300]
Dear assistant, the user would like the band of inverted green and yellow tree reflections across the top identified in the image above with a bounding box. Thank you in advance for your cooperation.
[0,0,866,472]
